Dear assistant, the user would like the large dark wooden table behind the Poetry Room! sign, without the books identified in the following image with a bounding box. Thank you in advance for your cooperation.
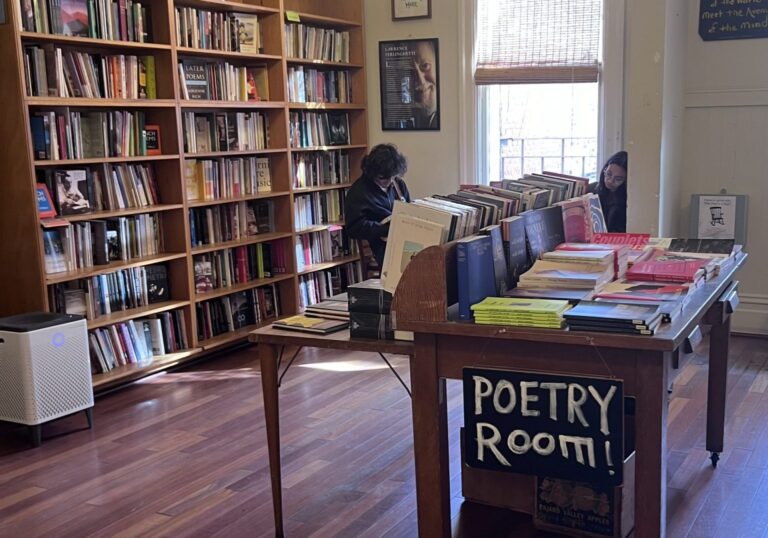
[392,245,746,538]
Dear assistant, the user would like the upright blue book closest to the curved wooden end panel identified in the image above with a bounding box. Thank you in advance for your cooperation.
[456,235,496,320]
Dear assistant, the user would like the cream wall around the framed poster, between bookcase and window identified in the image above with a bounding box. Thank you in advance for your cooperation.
[365,0,464,196]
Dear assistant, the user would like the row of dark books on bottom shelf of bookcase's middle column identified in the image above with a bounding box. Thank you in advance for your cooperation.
[195,284,280,340]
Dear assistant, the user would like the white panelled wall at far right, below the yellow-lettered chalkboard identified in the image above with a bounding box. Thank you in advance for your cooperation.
[679,0,768,334]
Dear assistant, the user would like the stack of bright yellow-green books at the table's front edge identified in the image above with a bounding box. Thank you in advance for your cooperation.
[472,297,571,329]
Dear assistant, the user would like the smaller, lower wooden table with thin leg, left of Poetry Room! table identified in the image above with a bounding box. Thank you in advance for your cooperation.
[248,327,413,536]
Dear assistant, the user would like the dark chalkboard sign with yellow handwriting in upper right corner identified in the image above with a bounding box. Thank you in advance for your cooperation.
[699,0,768,41]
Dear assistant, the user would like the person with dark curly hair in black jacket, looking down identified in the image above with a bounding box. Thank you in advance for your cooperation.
[344,144,411,267]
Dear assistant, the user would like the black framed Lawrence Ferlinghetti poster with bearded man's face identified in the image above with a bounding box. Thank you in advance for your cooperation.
[379,38,440,131]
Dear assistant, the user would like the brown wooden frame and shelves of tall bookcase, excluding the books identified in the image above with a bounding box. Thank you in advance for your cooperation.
[0,0,368,391]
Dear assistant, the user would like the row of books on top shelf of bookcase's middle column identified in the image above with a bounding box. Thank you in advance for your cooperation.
[176,6,264,54]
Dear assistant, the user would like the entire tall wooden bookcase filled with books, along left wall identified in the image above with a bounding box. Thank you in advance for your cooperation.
[0,0,367,390]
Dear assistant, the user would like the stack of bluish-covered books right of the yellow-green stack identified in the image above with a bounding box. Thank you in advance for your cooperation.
[563,301,662,335]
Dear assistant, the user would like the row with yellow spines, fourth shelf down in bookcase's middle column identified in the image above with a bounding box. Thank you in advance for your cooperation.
[184,157,272,201]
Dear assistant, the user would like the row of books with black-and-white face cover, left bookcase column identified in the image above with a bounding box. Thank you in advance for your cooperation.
[37,164,160,215]
